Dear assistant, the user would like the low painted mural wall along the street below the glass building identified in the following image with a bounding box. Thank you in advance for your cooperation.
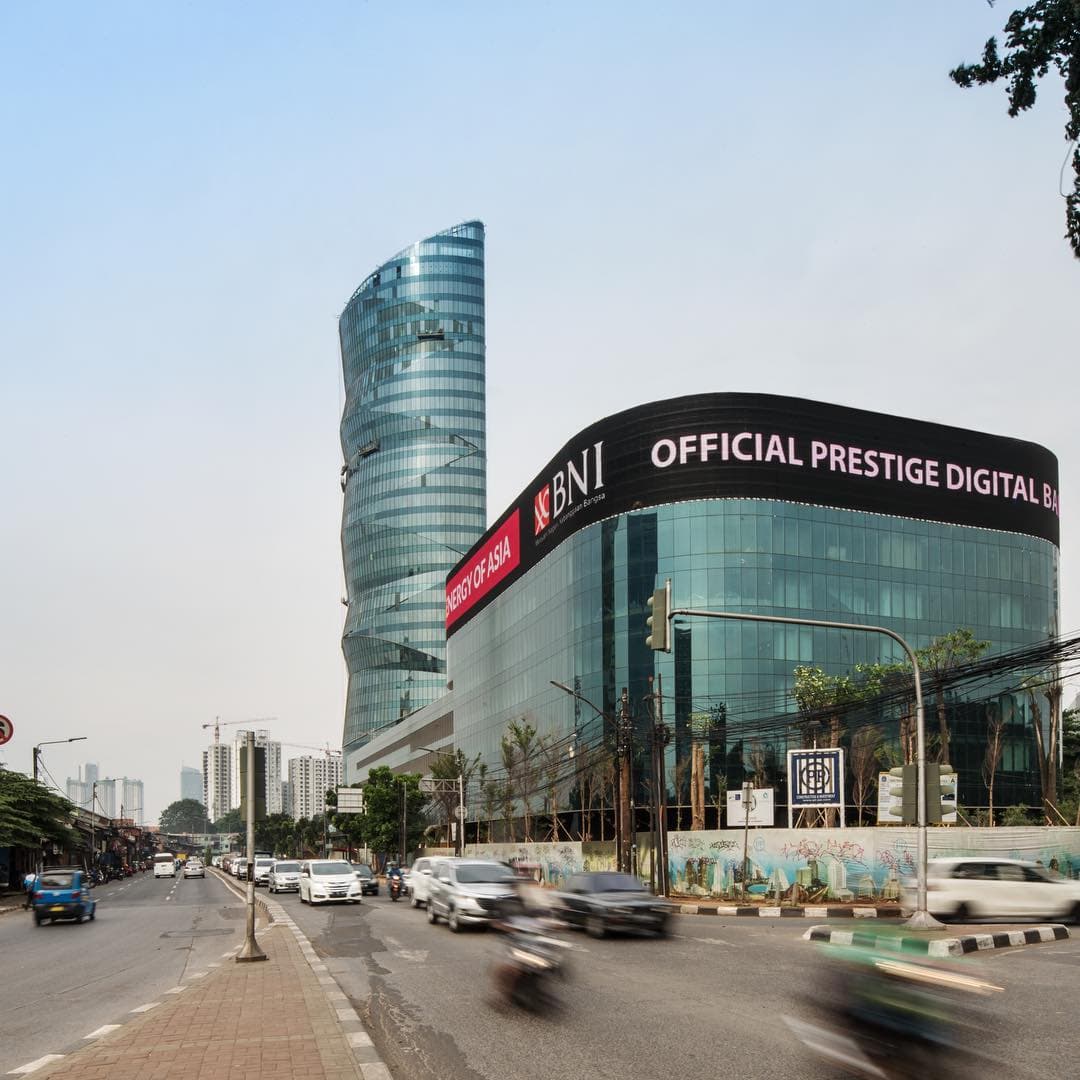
[465,827,1080,904]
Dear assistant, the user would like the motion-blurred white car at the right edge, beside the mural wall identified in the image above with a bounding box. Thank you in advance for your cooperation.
[902,856,1080,922]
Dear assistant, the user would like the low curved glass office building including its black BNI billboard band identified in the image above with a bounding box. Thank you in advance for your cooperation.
[354,393,1058,806]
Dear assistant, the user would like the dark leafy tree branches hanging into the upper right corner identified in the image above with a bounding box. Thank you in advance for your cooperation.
[949,0,1080,258]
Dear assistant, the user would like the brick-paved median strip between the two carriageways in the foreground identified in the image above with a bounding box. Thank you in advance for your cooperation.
[30,923,373,1080]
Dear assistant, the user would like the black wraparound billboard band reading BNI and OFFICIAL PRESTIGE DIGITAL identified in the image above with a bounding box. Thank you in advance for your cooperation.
[446,394,1059,634]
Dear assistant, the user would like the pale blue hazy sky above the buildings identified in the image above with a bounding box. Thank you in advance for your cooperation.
[0,0,1080,819]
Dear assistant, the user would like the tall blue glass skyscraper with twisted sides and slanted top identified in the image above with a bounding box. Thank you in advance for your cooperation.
[338,221,487,764]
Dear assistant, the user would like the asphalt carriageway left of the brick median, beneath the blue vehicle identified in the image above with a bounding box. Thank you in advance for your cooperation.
[0,870,244,1076]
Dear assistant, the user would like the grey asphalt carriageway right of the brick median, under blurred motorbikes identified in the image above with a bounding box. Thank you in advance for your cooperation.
[279,894,1080,1080]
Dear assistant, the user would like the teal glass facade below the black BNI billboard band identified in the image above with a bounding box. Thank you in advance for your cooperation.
[450,499,1058,806]
